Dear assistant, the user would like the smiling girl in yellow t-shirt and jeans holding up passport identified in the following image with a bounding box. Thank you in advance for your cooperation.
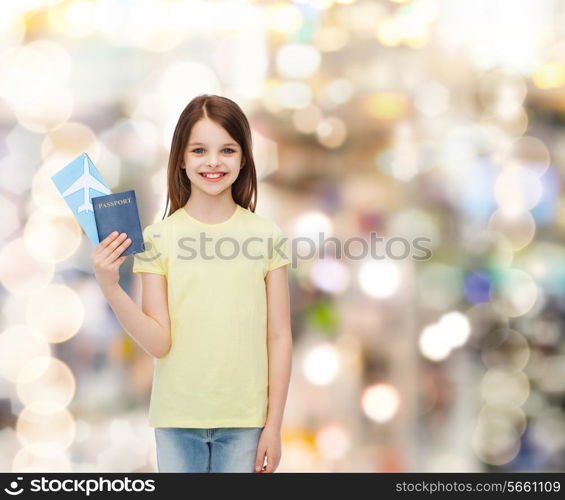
[91,95,292,472]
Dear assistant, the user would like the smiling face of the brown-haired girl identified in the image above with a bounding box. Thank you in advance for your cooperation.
[182,118,242,195]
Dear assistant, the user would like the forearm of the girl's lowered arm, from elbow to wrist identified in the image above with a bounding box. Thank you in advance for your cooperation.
[265,333,292,430]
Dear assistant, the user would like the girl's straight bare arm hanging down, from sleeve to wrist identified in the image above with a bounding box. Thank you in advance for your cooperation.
[265,266,292,431]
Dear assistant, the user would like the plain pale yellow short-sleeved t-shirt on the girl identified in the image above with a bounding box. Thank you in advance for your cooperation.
[133,205,290,428]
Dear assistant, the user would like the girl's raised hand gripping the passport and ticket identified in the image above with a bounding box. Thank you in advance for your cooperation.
[90,231,131,289]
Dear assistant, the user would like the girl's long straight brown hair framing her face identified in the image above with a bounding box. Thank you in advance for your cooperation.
[163,94,257,219]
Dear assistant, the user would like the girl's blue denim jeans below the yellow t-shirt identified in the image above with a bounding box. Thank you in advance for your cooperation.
[155,427,263,472]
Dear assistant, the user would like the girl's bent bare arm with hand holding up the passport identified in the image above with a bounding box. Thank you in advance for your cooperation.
[91,230,171,358]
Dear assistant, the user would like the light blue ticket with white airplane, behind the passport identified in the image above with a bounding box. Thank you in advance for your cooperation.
[51,153,112,245]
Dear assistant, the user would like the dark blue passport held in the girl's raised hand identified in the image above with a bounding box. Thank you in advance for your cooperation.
[92,189,145,257]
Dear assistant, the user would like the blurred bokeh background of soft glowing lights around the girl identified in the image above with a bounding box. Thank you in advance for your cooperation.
[0,0,565,472]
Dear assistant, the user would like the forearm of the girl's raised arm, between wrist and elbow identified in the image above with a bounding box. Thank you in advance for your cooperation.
[102,284,170,358]
